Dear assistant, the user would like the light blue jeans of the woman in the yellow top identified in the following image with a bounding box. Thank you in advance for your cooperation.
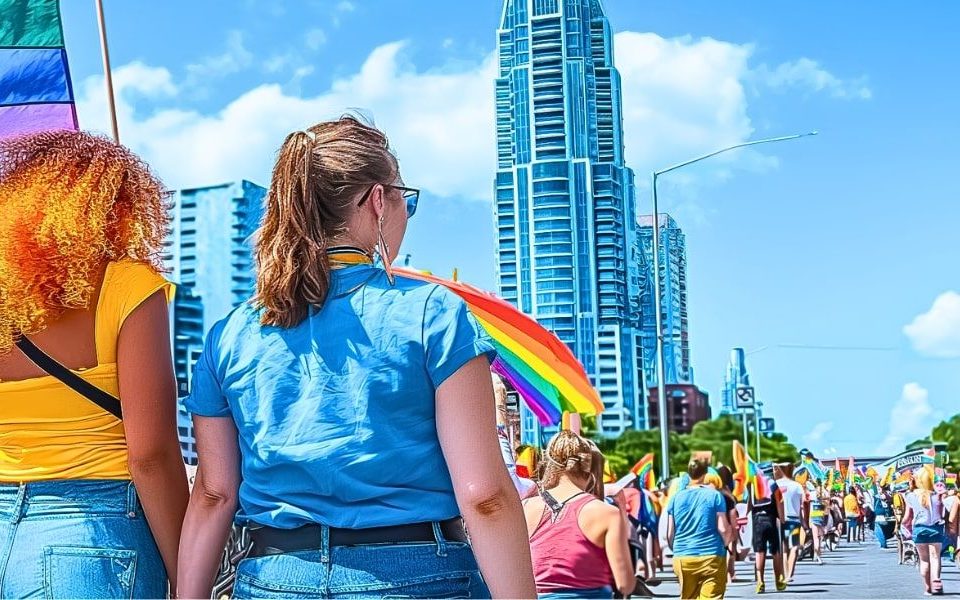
[0,480,167,598]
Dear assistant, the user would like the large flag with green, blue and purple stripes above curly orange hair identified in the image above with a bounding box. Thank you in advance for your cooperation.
[0,0,77,138]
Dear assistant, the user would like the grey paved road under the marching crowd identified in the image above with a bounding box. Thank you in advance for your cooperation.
[653,543,960,600]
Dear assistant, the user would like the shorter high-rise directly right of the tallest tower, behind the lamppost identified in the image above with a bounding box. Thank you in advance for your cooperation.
[640,213,693,386]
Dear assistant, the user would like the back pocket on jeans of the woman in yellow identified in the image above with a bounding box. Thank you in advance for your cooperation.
[43,546,137,598]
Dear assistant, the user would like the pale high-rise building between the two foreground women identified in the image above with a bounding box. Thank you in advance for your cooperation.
[164,181,266,464]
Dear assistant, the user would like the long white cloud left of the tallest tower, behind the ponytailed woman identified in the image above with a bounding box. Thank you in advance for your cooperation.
[77,42,495,198]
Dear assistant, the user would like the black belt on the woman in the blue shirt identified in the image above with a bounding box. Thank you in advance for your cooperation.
[250,517,467,557]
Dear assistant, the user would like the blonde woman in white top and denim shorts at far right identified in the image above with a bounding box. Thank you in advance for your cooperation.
[903,467,943,595]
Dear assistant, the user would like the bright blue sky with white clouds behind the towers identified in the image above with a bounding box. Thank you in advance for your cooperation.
[56,0,960,456]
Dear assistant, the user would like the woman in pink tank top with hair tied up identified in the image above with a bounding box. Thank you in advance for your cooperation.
[524,431,636,599]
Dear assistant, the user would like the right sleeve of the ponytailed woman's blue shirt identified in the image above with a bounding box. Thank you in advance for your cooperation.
[423,287,496,388]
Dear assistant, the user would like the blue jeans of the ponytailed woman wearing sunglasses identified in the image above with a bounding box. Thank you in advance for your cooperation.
[233,525,490,598]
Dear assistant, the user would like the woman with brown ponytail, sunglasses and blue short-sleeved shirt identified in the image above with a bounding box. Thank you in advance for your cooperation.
[178,116,536,598]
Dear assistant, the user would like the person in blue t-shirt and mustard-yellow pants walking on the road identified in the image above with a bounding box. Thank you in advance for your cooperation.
[667,458,735,598]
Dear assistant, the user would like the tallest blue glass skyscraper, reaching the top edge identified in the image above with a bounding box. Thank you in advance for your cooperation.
[494,0,647,441]
